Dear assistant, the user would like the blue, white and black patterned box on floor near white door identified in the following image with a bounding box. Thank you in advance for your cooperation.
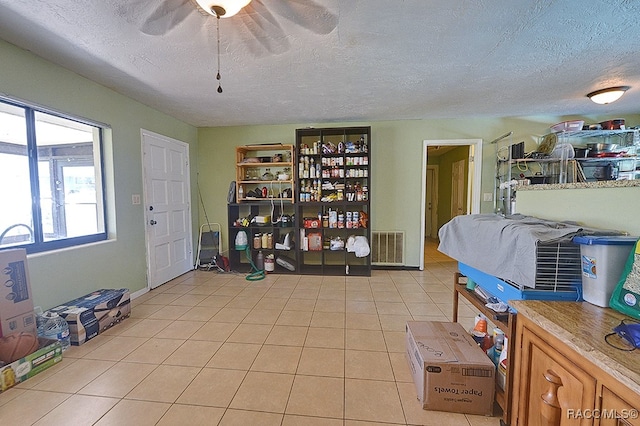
[50,288,131,346]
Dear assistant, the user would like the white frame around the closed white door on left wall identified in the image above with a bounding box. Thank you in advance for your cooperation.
[140,129,194,290]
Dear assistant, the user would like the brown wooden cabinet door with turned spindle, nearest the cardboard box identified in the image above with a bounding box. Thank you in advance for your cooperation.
[515,327,596,426]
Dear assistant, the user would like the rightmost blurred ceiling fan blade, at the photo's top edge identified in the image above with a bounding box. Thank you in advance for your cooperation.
[269,0,338,34]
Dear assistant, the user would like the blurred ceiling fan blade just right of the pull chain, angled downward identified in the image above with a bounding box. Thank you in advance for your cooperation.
[236,0,289,56]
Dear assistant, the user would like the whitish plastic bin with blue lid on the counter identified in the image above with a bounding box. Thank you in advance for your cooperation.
[573,235,638,308]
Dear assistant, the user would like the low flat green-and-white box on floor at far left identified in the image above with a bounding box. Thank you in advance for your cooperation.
[0,337,62,393]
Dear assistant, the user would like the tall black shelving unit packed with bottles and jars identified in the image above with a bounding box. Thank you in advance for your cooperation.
[296,127,371,276]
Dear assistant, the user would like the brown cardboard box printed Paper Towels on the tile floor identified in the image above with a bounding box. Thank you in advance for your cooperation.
[406,321,496,416]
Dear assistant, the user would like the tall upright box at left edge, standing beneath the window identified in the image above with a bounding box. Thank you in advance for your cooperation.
[0,249,36,337]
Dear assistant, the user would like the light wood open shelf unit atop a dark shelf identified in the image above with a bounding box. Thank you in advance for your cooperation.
[236,144,295,203]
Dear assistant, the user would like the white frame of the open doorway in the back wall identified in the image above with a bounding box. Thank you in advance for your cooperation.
[420,139,482,271]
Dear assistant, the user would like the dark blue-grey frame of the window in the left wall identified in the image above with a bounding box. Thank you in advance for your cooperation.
[0,94,111,254]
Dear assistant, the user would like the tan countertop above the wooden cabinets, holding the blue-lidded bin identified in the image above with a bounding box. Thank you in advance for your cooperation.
[509,300,640,394]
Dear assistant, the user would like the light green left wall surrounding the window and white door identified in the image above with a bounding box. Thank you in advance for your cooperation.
[0,40,198,309]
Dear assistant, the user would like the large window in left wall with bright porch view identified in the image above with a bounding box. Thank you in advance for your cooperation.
[0,101,106,253]
